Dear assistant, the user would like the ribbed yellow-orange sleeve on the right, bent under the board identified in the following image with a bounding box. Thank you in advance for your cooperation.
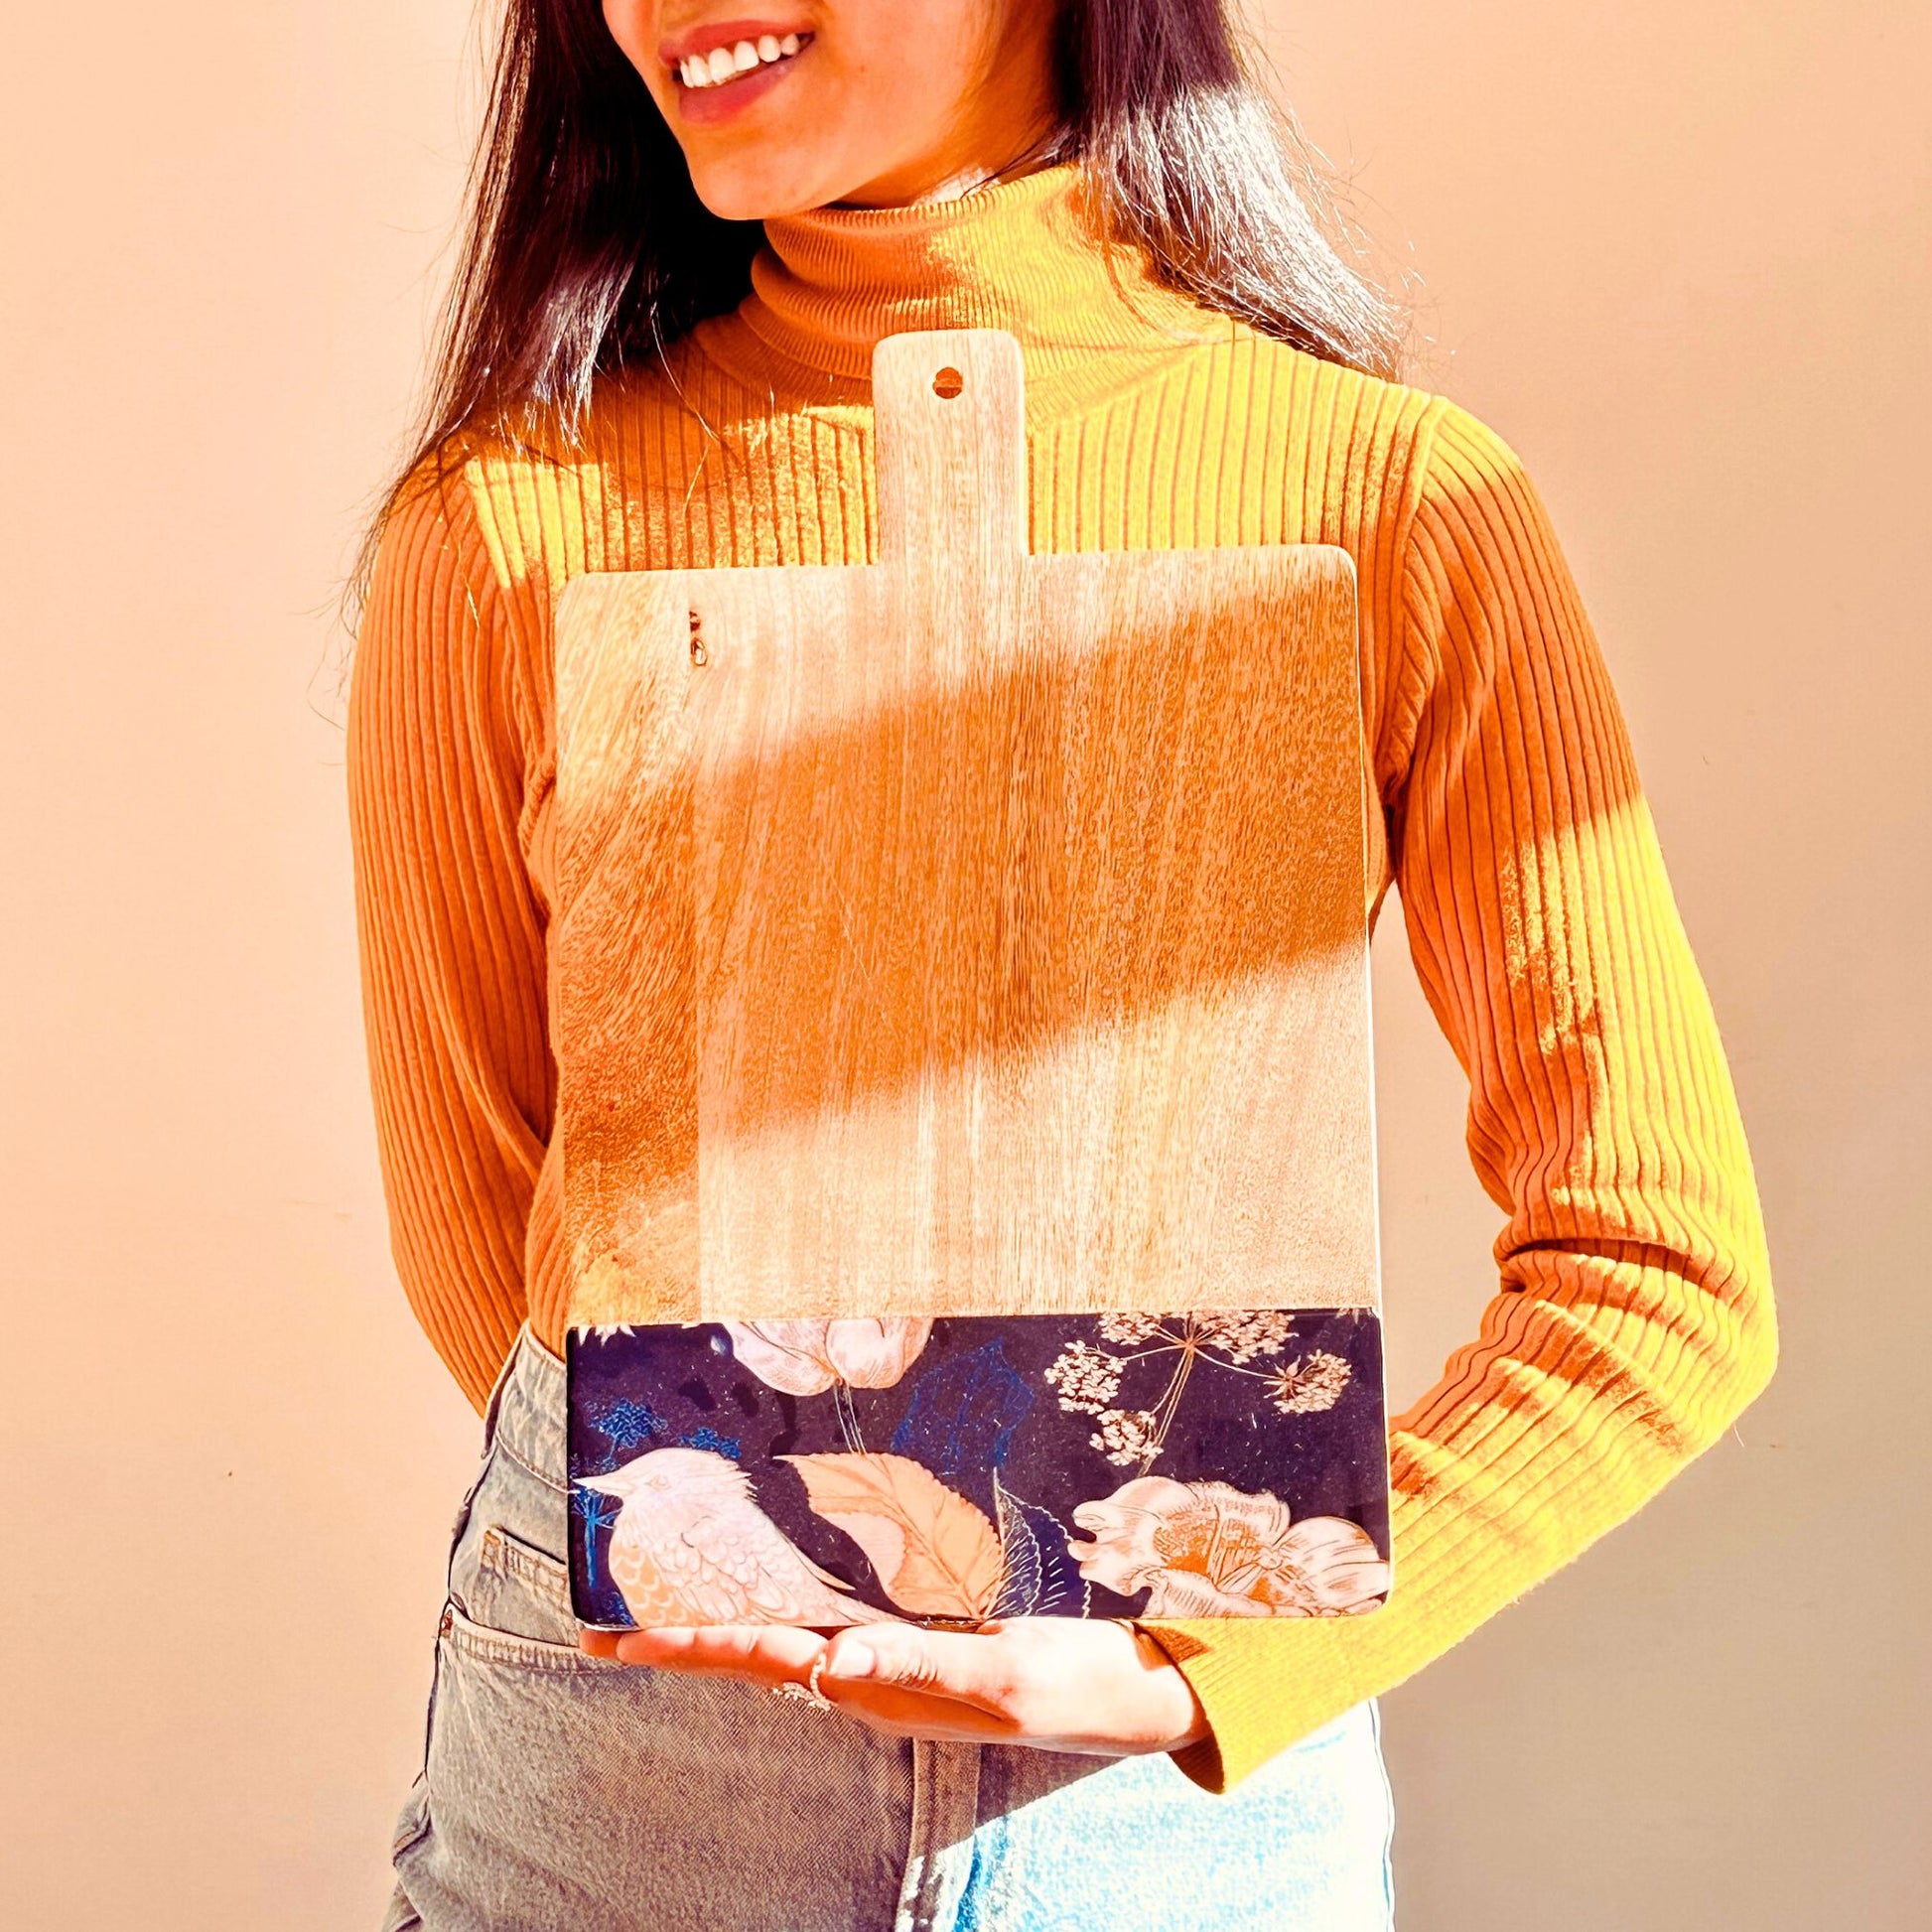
[1150,404,1777,1791]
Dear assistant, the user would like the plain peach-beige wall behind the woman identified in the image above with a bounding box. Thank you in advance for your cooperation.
[0,0,1932,1932]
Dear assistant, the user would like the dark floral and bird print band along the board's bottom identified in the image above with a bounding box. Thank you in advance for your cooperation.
[568,1308,1391,1627]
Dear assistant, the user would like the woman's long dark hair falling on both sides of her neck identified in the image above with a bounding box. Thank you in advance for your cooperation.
[351,0,1401,595]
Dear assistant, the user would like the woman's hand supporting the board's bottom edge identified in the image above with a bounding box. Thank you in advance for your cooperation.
[582,1617,1207,1758]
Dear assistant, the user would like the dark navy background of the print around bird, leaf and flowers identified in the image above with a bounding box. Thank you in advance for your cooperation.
[566,1308,1389,1625]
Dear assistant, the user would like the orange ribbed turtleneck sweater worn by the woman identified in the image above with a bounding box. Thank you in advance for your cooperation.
[347,162,1777,1791]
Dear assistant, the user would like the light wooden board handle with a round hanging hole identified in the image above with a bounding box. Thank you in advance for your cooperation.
[872,329,1026,570]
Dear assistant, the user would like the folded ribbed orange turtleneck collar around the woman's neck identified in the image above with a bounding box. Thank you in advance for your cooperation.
[698,161,1233,413]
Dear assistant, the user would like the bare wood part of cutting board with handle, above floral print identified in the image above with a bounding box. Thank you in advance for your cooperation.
[551,329,1379,1325]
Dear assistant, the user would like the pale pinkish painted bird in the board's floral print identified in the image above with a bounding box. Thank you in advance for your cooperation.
[578,1449,906,1628]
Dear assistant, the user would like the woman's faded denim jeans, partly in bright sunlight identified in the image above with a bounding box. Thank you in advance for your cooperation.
[384,1331,1393,1932]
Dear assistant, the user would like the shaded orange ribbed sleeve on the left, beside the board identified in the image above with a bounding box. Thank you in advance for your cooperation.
[347,476,555,1409]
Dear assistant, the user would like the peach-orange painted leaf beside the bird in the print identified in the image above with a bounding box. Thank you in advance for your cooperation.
[776,1452,1001,1617]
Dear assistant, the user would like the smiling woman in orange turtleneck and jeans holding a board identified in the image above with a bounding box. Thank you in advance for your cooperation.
[349,0,1775,1932]
